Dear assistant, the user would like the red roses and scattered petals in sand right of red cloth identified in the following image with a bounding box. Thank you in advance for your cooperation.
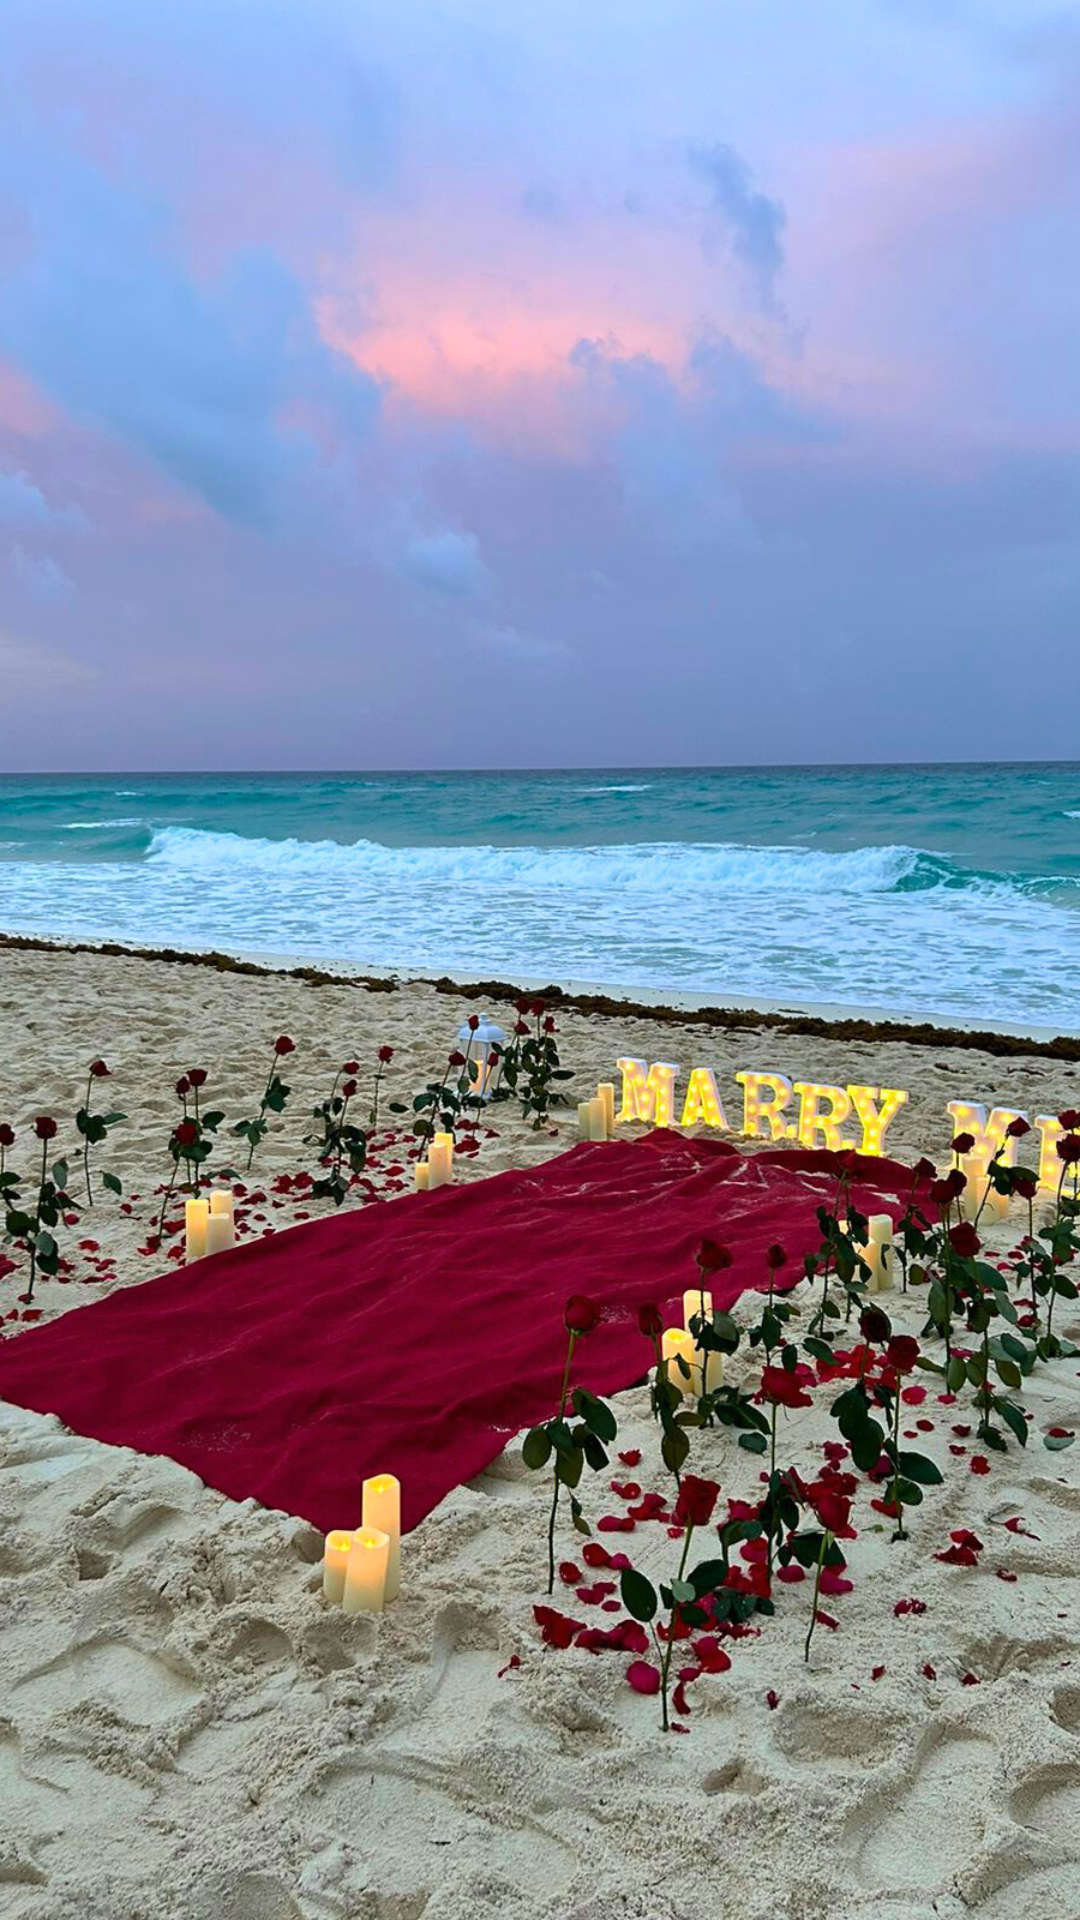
[523,1112,1080,1732]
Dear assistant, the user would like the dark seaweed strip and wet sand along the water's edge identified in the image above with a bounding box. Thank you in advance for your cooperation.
[0,929,1080,1062]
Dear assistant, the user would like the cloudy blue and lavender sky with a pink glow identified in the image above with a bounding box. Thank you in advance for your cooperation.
[0,0,1080,772]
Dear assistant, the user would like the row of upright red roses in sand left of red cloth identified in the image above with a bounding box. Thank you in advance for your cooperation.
[0,1000,573,1319]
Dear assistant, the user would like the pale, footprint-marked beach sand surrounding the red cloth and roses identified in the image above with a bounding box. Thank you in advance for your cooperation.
[0,948,1080,1920]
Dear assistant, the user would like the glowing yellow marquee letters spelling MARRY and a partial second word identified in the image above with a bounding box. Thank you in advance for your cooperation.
[615,1056,1065,1192]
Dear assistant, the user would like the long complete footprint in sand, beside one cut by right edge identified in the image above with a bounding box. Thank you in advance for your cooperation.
[847,1734,995,1891]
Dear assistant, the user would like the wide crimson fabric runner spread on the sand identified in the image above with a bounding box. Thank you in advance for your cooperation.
[0,1133,911,1530]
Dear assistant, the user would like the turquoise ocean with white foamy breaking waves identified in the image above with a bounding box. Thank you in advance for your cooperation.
[0,764,1080,1033]
